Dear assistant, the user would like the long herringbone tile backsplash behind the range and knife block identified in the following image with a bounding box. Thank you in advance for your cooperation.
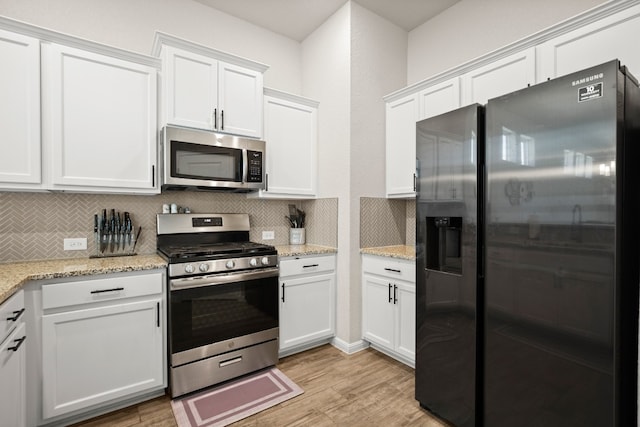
[0,192,338,262]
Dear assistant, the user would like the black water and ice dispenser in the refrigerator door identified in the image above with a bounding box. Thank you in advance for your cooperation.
[426,216,462,274]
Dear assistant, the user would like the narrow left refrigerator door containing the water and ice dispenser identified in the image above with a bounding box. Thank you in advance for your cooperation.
[416,105,483,426]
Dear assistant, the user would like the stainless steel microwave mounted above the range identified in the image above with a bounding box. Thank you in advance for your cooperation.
[159,126,265,192]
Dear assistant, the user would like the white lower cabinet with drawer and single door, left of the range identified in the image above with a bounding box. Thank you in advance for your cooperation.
[36,270,166,423]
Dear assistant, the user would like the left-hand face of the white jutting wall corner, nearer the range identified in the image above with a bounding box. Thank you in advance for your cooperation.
[302,3,352,342]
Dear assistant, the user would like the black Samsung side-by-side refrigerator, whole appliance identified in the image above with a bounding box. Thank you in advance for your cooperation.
[416,61,640,427]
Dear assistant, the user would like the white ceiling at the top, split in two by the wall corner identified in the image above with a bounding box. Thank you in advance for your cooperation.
[195,0,460,41]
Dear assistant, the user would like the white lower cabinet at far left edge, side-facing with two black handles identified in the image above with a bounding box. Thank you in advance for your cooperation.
[0,291,26,427]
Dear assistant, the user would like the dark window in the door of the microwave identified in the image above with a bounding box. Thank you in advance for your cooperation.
[171,141,242,182]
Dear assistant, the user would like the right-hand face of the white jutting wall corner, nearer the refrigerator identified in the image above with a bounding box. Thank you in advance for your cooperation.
[349,2,407,342]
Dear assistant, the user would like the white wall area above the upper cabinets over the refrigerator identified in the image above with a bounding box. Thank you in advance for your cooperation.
[408,0,605,85]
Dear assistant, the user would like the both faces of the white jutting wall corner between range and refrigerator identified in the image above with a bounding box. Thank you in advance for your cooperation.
[302,2,407,344]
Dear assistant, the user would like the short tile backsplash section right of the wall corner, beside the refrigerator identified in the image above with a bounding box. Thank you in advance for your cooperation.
[360,197,415,248]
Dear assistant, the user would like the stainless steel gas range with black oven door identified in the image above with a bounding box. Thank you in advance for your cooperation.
[157,214,278,397]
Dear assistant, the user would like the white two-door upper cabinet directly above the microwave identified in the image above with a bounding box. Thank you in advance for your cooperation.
[154,32,267,138]
